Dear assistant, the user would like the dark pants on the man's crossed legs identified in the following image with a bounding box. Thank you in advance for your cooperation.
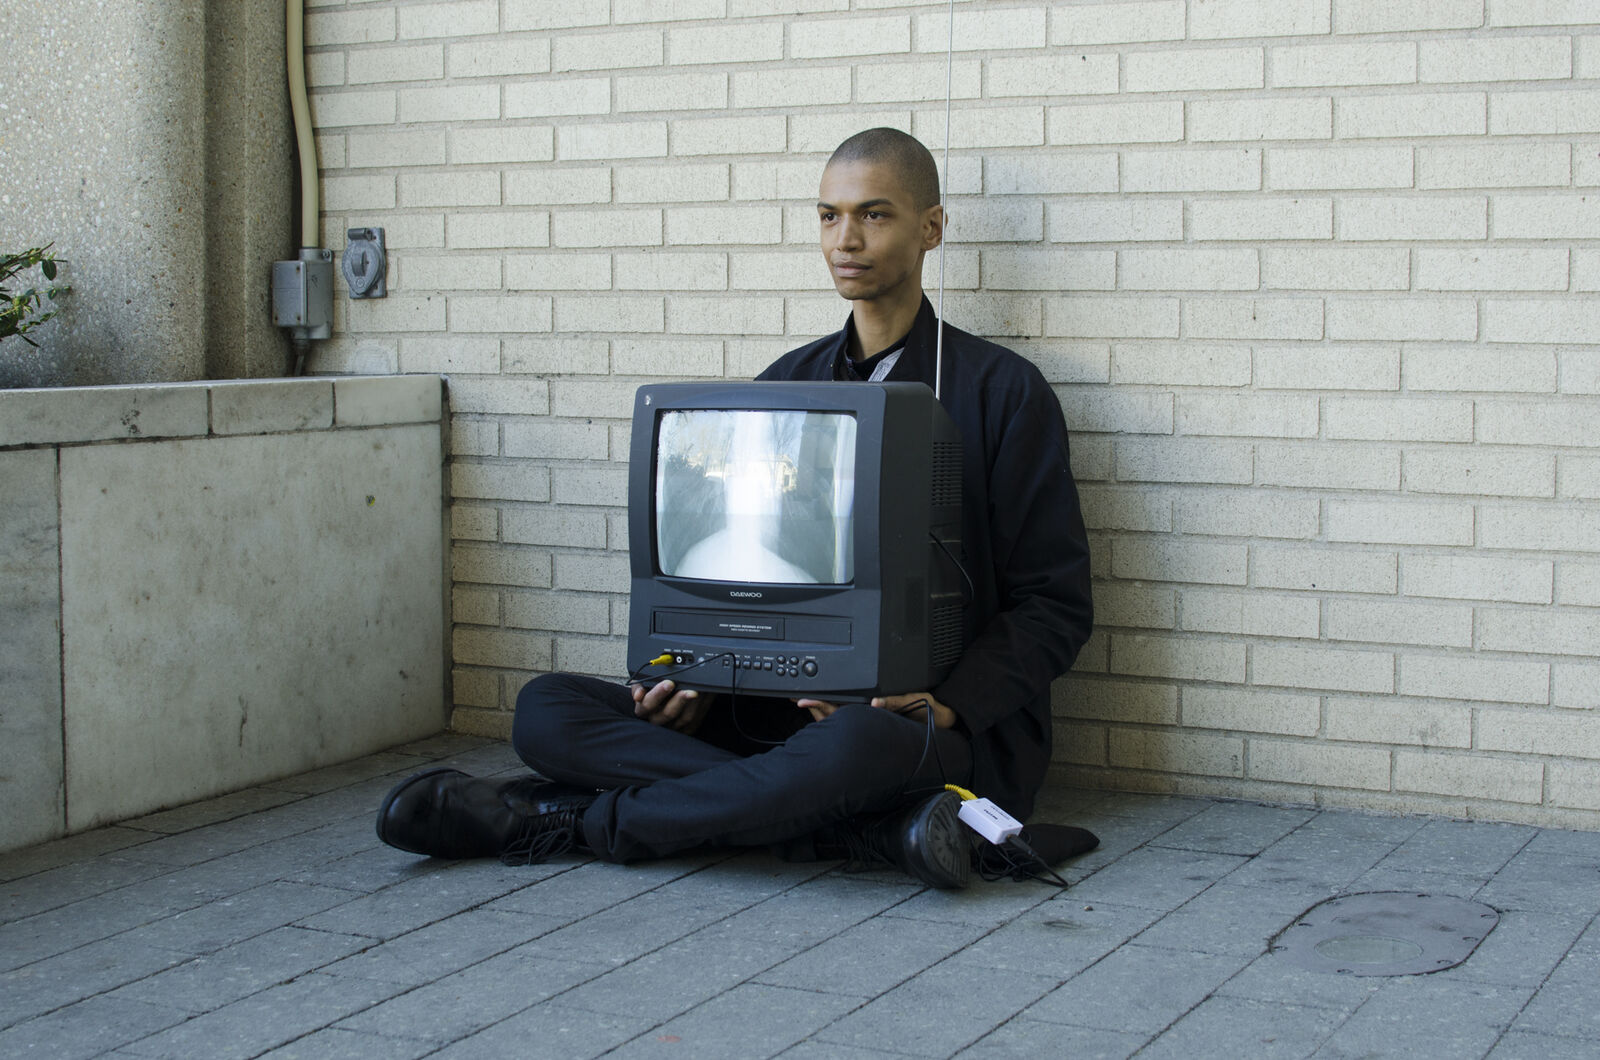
[512,674,973,861]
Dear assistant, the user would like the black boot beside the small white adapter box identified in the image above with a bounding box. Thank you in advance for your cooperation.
[814,791,973,889]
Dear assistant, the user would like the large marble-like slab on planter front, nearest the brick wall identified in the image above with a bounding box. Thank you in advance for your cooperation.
[61,424,445,831]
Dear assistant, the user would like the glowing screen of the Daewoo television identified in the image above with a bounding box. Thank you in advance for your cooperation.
[656,408,856,584]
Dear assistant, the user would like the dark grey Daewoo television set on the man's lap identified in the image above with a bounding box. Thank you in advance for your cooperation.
[627,381,970,703]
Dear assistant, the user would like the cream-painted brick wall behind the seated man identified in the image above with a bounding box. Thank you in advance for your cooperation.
[309,0,1600,826]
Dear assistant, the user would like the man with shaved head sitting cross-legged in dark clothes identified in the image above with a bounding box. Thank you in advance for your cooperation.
[378,128,1093,887]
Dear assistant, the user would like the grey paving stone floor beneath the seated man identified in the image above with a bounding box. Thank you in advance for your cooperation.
[0,735,1600,1060]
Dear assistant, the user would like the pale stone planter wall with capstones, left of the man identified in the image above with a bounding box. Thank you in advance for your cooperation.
[0,376,446,850]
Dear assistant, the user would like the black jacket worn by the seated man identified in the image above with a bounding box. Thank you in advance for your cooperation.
[757,298,1094,818]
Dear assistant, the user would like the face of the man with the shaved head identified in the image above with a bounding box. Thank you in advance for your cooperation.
[816,162,941,301]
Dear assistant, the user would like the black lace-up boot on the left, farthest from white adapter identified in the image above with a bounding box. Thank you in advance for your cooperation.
[378,769,595,863]
